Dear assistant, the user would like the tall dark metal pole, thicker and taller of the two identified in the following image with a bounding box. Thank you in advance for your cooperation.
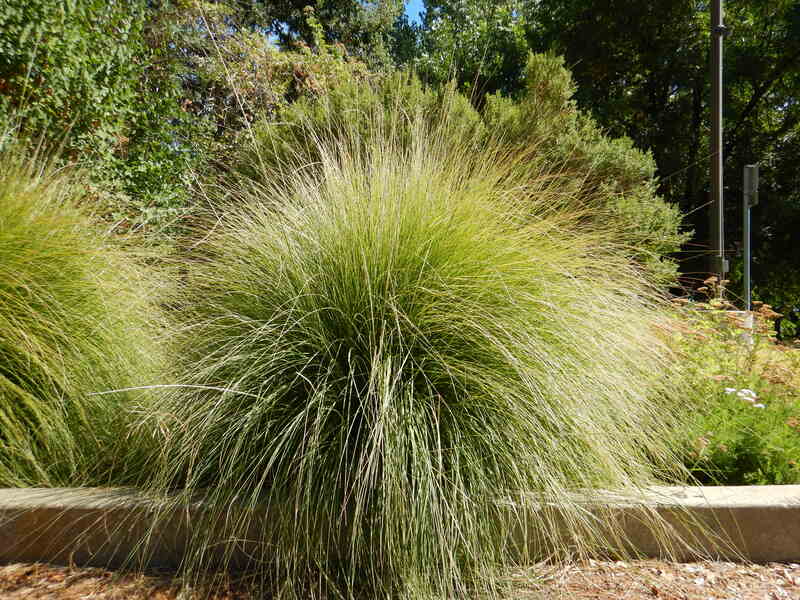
[709,0,728,281]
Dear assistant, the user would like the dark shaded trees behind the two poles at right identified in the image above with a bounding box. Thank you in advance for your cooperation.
[526,0,800,312]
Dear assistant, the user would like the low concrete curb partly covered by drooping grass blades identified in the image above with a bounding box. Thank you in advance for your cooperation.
[0,485,800,568]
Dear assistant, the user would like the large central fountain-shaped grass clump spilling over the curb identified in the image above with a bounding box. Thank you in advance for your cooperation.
[153,125,688,598]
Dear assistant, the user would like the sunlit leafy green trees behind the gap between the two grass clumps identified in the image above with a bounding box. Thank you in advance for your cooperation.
[0,0,382,232]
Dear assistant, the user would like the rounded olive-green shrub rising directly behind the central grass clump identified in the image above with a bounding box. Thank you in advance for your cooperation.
[245,55,688,284]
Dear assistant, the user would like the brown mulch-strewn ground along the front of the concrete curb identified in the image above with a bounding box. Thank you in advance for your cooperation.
[0,560,800,600]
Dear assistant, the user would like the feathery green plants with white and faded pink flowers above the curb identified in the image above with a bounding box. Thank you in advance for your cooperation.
[676,296,800,485]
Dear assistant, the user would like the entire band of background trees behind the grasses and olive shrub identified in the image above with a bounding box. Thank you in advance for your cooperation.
[0,0,800,324]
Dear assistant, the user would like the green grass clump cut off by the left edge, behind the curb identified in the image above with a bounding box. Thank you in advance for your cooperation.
[0,148,165,486]
